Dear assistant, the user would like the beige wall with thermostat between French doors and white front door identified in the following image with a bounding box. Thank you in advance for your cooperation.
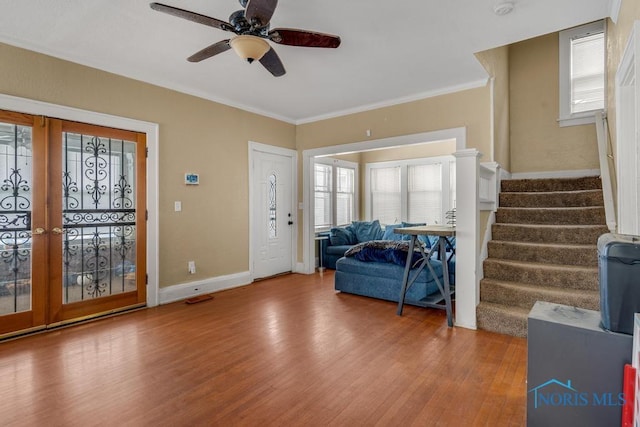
[0,44,295,287]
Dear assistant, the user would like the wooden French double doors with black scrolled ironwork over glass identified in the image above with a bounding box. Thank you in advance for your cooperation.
[0,111,146,336]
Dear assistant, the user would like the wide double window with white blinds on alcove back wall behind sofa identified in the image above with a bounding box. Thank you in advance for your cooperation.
[366,156,456,224]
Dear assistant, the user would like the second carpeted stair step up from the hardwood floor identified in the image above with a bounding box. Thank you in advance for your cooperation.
[480,279,600,310]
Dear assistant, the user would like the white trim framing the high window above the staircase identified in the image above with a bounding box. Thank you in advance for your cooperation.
[558,21,607,127]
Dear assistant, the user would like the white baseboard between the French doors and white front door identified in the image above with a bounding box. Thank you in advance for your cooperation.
[159,271,252,304]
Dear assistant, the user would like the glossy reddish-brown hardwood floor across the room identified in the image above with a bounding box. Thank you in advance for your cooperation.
[0,272,526,426]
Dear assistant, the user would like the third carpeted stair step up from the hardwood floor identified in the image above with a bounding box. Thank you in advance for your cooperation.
[483,258,598,290]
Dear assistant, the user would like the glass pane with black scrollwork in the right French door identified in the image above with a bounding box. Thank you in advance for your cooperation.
[62,132,136,304]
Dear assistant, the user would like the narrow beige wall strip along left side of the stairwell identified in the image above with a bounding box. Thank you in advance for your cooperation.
[476,46,511,170]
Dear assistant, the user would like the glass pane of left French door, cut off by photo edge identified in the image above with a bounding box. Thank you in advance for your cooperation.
[0,123,32,315]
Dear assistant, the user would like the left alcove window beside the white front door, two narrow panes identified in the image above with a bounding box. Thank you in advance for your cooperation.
[314,158,358,230]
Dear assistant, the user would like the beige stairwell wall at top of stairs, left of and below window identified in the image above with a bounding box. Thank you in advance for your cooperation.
[509,33,600,173]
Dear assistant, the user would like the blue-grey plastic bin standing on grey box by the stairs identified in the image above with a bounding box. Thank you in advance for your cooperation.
[598,233,640,334]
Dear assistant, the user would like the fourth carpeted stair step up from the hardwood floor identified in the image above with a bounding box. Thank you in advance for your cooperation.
[488,240,598,267]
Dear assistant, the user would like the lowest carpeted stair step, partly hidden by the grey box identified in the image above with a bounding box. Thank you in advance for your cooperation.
[476,301,530,337]
